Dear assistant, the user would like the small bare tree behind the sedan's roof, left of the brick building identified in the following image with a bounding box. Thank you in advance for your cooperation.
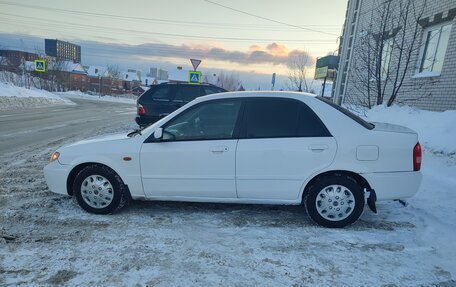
[287,53,315,92]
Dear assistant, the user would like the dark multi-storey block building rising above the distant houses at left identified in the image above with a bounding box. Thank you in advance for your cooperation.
[44,39,81,63]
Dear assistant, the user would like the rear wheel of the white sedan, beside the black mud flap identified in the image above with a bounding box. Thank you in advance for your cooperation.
[304,174,365,228]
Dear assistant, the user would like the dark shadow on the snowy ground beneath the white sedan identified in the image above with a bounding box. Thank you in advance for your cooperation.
[104,201,415,231]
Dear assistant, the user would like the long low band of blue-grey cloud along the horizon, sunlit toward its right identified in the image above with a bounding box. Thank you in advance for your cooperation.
[0,34,314,66]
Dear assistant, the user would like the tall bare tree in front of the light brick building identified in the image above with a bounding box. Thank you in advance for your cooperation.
[347,0,426,108]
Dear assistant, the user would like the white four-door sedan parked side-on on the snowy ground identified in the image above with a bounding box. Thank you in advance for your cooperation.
[44,92,421,227]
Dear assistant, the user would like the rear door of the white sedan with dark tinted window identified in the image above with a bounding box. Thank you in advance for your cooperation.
[236,98,336,200]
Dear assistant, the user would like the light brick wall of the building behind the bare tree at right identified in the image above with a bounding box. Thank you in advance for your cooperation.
[333,0,456,111]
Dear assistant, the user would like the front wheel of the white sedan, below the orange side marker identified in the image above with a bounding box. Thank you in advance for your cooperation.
[73,164,129,214]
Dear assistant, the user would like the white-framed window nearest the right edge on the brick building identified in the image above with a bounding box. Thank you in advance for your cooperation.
[418,23,452,75]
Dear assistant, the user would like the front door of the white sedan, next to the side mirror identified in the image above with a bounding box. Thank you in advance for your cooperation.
[140,99,242,199]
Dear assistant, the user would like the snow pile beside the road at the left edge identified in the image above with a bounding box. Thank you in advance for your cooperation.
[0,83,73,110]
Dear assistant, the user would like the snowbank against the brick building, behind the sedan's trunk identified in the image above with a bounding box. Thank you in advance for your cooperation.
[361,105,456,155]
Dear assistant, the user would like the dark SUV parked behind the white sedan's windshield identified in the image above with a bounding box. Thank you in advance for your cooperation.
[136,83,227,127]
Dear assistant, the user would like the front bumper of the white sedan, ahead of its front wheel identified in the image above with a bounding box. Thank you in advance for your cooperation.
[44,160,72,195]
